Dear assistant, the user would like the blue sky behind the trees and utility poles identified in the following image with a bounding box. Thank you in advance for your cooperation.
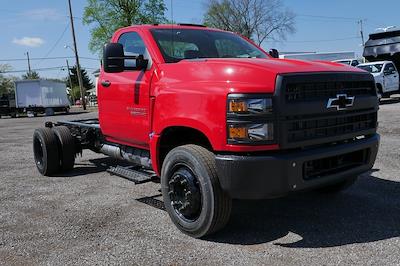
[0,0,400,81]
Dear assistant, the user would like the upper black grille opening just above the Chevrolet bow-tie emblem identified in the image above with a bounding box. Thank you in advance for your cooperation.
[285,81,376,102]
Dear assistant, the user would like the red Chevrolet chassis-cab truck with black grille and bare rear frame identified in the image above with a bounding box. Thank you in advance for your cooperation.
[33,24,379,237]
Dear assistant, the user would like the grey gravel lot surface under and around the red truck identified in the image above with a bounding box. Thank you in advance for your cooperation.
[0,99,400,265]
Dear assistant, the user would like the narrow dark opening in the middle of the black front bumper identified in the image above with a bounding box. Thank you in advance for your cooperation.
[303,149,370,180]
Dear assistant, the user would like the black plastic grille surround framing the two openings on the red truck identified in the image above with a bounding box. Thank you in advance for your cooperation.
[273,72,379,149]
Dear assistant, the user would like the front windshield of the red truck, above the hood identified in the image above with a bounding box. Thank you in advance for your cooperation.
[151,29,268,63]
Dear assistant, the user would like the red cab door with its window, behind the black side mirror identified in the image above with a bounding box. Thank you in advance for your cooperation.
[98,32,152,148]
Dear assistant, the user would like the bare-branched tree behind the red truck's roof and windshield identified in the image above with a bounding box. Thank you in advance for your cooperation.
[204,0,295,45]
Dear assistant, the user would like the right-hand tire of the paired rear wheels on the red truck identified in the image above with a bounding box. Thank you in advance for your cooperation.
[52,126,75,171]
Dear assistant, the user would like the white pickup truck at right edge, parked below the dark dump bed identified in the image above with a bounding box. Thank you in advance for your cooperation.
[357,61,399,97]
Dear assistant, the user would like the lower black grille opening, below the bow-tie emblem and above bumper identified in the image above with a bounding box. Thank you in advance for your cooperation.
[288,113,377,143]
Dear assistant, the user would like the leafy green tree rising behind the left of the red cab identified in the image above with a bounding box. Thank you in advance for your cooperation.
[83,0,167,53]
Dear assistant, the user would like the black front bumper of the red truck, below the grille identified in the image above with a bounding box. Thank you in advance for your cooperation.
[216,134,379,199]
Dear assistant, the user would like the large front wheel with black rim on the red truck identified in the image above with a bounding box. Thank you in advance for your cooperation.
[161,145,232,238]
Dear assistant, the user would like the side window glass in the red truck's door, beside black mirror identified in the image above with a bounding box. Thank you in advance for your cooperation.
[118,32,146,67]
